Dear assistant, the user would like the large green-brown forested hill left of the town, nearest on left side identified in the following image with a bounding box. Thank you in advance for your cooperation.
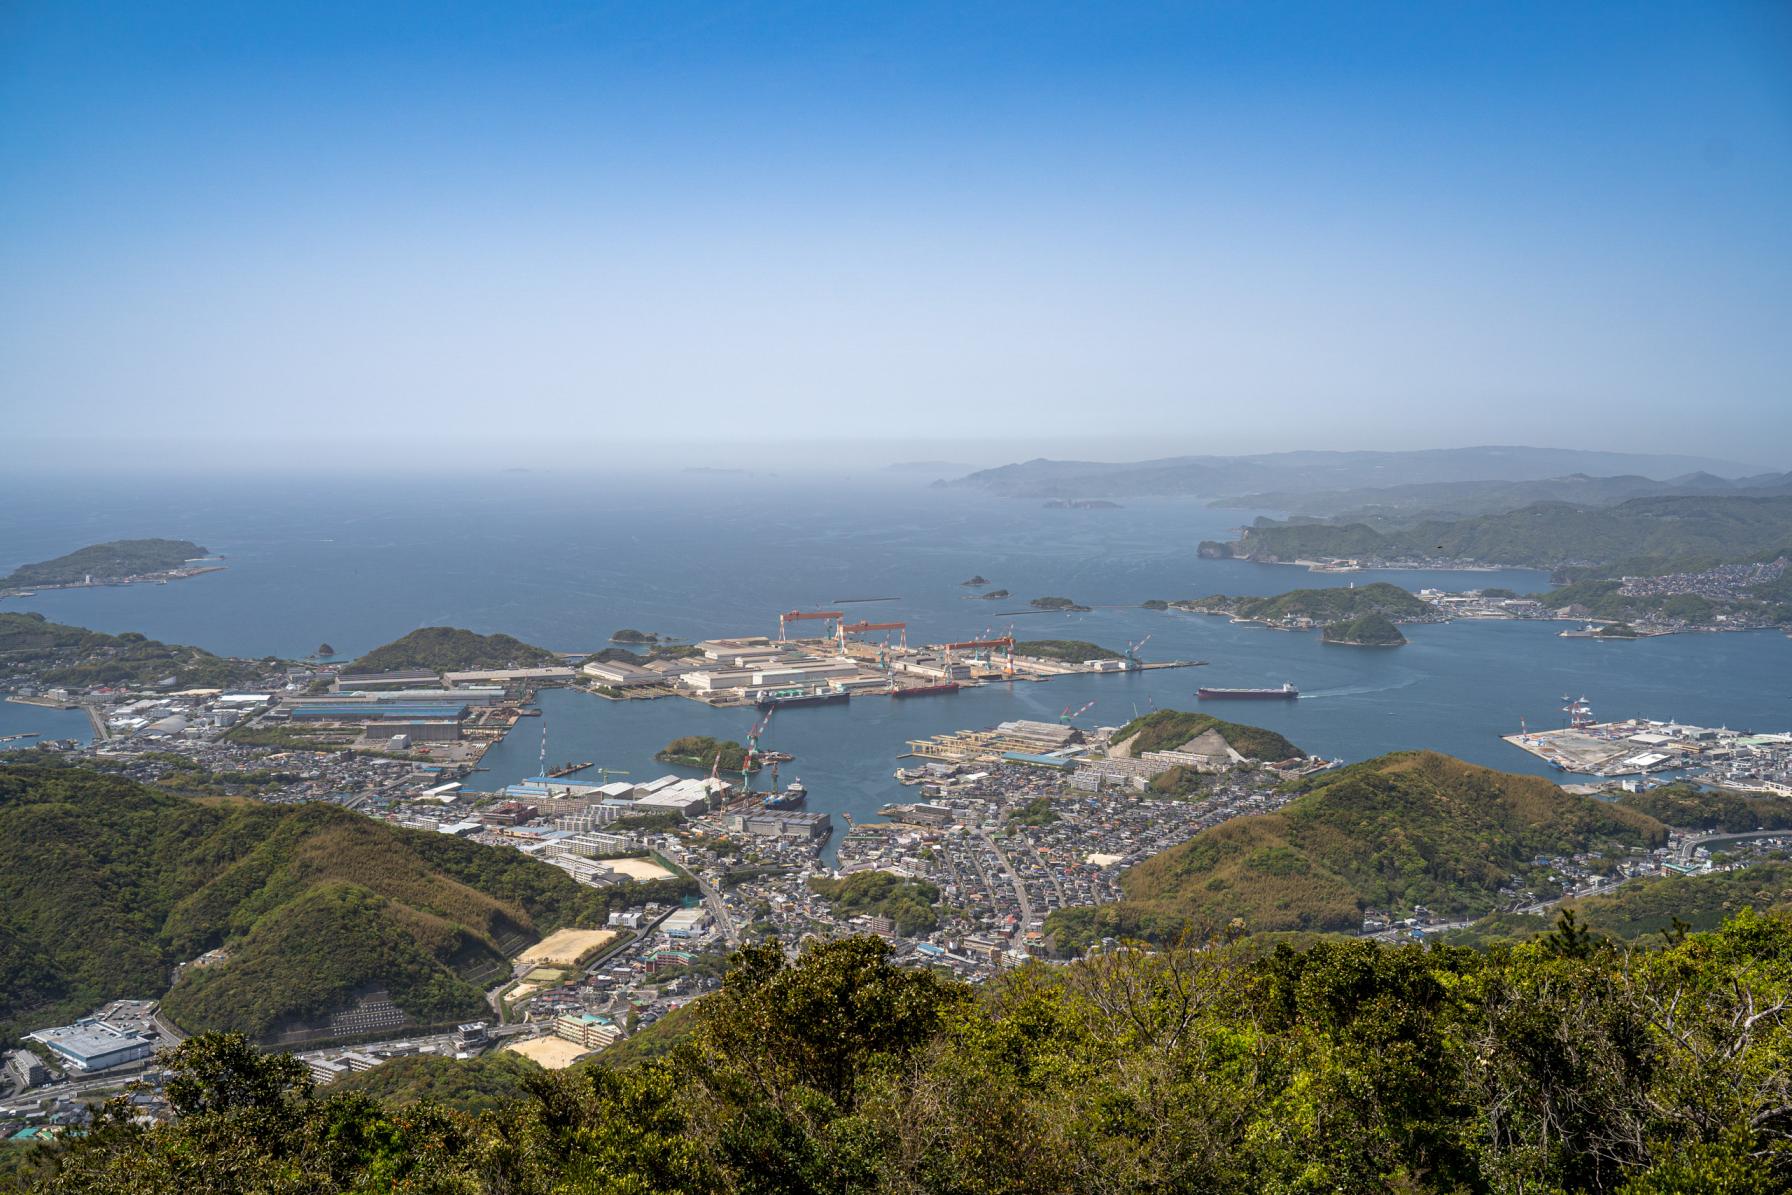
[0,767,681,1036]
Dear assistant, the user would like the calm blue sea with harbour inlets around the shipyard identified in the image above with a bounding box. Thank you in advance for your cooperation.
[0,468,1792,838]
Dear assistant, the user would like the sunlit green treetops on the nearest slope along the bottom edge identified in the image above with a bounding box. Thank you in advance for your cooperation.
[24,914,1792,1195]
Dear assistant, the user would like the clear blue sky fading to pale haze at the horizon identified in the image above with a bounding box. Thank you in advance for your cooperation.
[0,0,1792,468]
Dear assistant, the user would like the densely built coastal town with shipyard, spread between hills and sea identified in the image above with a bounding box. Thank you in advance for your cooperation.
[0,566,1792,1136]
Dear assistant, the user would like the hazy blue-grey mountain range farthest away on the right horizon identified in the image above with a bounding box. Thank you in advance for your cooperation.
[941,446,1762,502]
